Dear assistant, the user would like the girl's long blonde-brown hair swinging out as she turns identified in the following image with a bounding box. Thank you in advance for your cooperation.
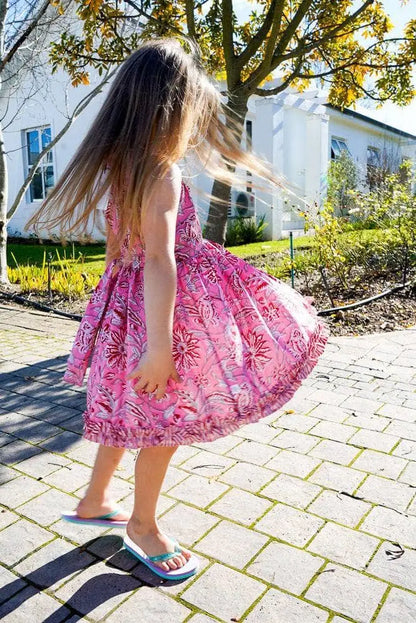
[25,38,281,250]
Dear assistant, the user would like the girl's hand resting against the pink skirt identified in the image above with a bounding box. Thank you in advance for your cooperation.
[127,351,182,400]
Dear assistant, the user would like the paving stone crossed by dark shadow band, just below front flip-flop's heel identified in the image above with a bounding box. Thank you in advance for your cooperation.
[55,562,140,621]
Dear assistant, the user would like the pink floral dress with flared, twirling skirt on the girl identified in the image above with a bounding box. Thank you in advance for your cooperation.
[64,184,329,448]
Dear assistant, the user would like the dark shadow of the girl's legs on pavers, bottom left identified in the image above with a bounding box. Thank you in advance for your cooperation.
[0,535,185,623]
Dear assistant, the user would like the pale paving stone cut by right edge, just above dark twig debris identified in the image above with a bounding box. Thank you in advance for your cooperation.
[360,506,416,547]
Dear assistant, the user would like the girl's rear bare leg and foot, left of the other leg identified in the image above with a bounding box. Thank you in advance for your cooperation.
[77,445,129,519]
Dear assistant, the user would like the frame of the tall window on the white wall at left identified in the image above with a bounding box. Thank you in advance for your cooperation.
[22,124,56,203]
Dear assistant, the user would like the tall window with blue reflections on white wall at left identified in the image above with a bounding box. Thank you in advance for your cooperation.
[24,126,55,201]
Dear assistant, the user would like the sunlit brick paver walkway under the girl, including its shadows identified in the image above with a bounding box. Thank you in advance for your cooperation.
[0,306,416,623]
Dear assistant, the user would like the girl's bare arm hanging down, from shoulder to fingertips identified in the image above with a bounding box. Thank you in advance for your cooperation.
[128,165,181,398]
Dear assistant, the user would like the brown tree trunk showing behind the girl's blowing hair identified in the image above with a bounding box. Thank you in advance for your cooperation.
[205,94,248,245]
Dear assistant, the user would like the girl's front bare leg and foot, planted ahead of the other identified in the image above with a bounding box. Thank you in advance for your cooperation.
[127,446,190,571]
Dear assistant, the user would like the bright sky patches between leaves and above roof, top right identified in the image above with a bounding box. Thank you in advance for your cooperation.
[234,0,416,134]
